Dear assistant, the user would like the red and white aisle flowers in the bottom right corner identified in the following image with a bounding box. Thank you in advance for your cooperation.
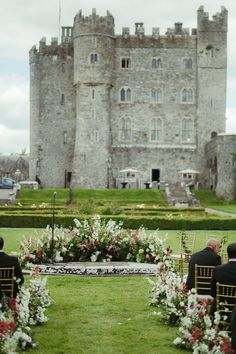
[174,289,234,354]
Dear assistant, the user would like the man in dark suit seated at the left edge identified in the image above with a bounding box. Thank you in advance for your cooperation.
[0,236,24,297]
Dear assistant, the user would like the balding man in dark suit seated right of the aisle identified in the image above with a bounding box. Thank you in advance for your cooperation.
[186,239,221,290]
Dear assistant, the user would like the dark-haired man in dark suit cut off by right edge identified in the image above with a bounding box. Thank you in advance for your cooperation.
[211,242,236,298]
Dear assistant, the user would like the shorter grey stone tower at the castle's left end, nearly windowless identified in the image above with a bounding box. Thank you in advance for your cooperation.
[30,36,75,187]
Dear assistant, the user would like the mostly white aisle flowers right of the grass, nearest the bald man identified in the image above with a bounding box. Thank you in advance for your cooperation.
[148,266,188,325]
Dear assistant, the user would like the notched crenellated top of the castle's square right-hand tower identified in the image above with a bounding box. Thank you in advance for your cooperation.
[197,6,228,32]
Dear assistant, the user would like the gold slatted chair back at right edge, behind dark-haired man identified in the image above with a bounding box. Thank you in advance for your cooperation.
[216,283,236,329]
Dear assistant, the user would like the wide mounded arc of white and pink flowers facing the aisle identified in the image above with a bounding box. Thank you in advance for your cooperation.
[21,215,171,265]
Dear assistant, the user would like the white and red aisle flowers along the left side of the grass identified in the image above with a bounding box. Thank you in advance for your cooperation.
[0,277,51,354]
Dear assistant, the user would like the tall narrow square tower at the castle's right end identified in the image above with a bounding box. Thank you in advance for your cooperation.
[197,6,228,171]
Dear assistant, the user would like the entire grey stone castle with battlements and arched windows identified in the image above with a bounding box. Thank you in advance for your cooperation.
[30,6,227,188]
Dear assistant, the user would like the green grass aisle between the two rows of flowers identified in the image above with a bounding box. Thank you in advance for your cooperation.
[20,276,186,354]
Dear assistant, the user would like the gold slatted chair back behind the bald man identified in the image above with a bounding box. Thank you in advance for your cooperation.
[194,264,215,295]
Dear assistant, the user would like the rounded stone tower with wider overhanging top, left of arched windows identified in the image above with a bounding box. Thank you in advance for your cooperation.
[72,9,115,188]
